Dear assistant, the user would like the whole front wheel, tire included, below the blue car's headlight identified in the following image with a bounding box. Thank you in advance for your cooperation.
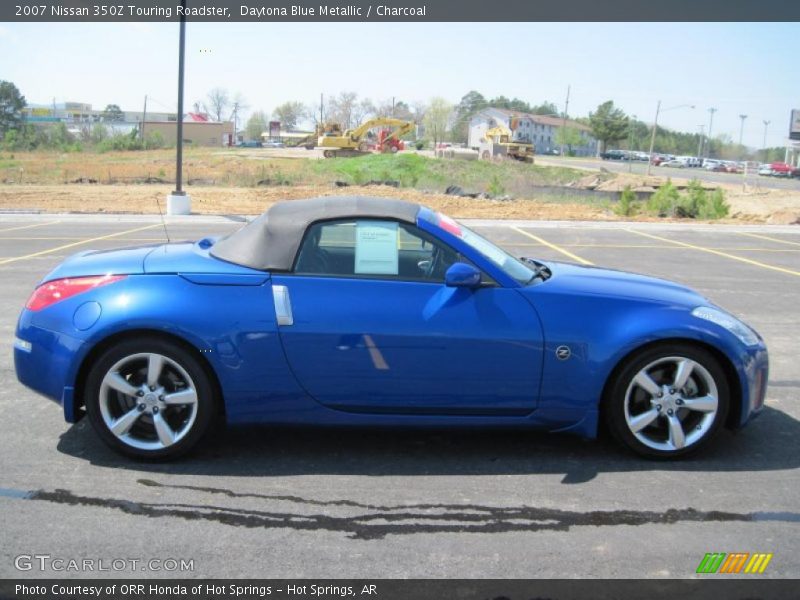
[605,344,730,459]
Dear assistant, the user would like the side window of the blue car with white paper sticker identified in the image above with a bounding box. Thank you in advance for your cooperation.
[294,219,463,282]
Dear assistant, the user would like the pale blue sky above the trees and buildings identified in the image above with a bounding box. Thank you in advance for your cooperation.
[0,23,800,147]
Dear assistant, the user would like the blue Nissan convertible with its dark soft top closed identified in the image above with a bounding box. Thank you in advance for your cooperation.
[14,197,767,458]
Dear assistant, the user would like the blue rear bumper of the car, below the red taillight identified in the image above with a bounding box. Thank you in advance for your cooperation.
[14,311,83,423]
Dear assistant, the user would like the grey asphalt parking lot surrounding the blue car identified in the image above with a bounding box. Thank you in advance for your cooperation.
[0,215,800,578]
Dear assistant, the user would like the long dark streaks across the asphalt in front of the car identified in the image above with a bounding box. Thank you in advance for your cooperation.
[9,480,800,540]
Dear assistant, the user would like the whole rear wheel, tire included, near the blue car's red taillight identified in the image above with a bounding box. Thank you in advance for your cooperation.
[85,338,215,459]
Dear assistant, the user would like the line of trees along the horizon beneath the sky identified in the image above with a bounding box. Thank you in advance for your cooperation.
[0,81,784,162]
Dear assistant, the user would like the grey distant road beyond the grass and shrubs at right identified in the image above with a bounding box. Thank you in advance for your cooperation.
[536,156,800,191]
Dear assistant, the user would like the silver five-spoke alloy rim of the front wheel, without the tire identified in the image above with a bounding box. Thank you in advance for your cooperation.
[625,356,719,452]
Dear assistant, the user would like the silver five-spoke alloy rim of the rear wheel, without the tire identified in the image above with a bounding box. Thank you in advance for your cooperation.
[99,353,197,450]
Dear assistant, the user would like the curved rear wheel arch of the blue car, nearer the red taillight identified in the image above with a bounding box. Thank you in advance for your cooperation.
[73,328,226,419]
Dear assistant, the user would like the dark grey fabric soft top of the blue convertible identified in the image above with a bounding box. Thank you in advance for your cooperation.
[211,196,420,271]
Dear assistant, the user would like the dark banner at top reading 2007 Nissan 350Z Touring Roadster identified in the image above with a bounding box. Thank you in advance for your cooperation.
[0,0,800,22]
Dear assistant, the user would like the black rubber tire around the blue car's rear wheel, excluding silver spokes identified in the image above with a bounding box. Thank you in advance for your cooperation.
[84,337,218,460]
